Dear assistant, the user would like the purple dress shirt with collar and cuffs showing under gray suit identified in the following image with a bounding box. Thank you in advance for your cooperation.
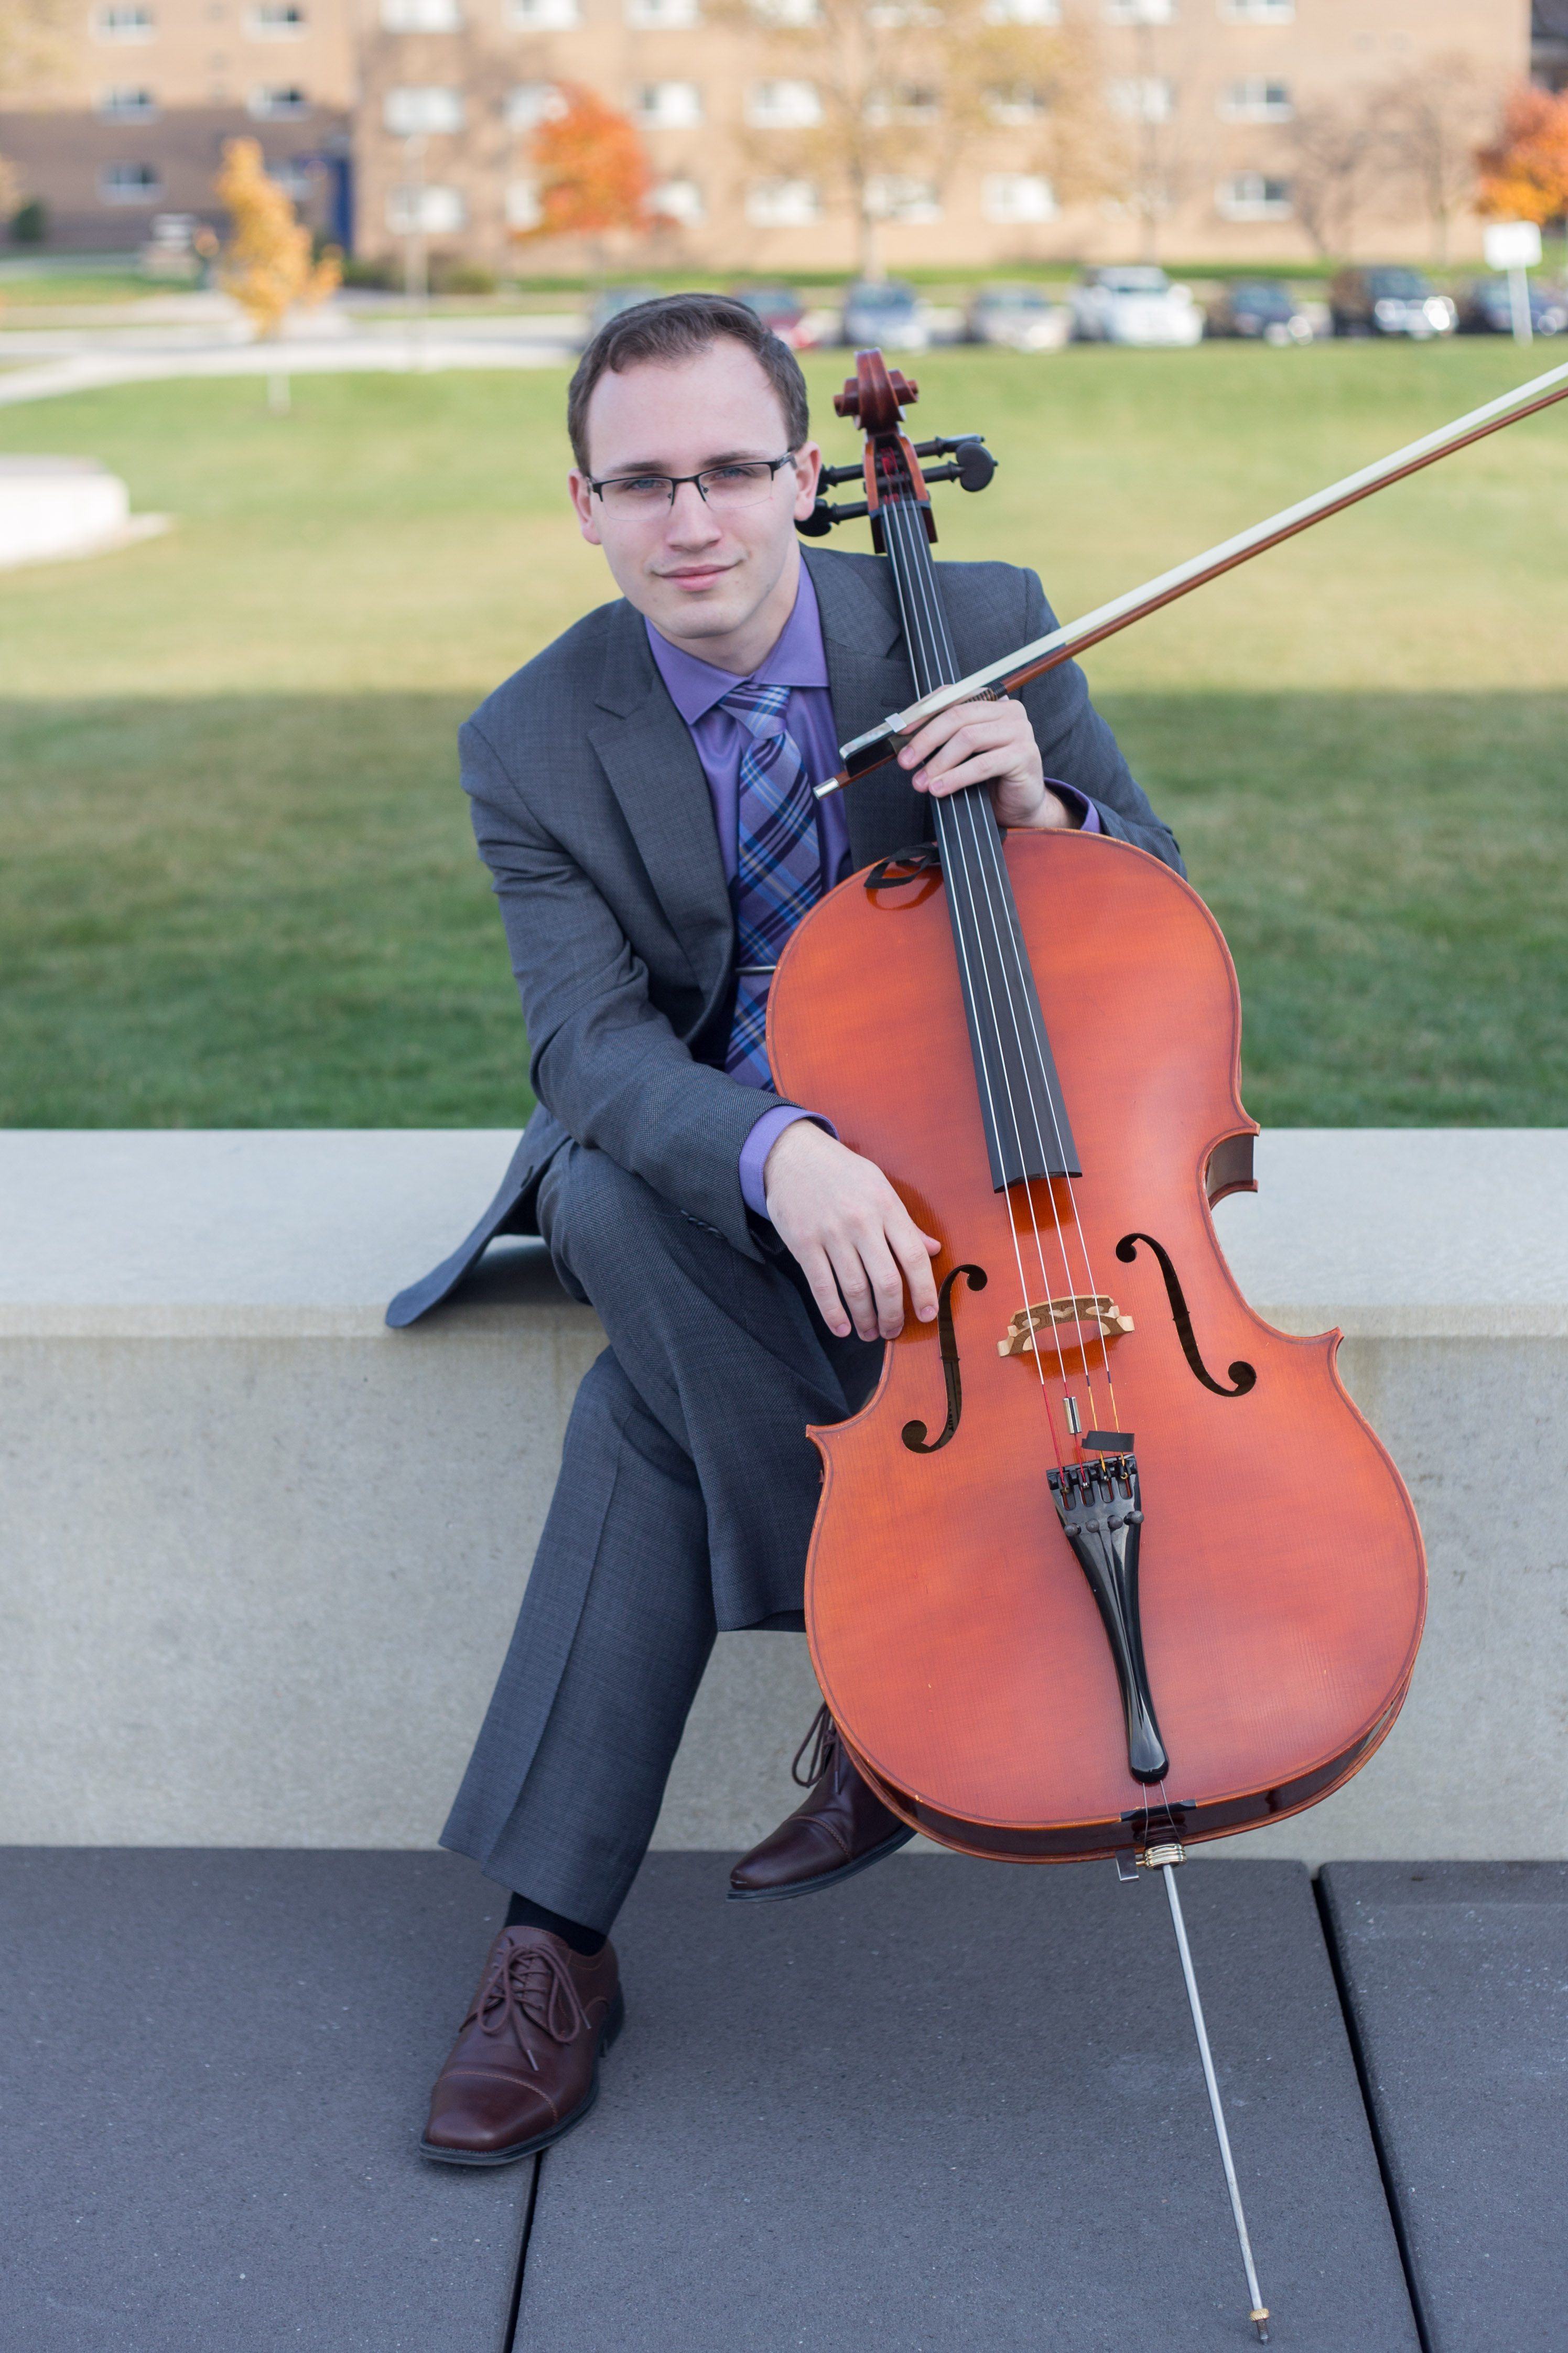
[643,565,1099,1219]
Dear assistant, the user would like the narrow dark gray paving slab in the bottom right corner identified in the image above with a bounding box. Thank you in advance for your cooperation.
[1323,1863,1568,2353]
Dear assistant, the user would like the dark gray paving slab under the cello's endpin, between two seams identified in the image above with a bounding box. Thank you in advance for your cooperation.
[518,1854,1418,2353]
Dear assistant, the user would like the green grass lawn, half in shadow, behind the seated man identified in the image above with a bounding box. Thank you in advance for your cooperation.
[0,341,1568,1127]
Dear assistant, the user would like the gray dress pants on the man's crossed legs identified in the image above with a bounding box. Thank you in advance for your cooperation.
[440,1143,883,1929]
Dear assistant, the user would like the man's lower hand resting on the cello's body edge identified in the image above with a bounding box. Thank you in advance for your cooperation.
[763,1120,942,1339]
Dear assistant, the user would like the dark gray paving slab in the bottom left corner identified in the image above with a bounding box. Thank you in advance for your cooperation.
[0,1847,532,2353]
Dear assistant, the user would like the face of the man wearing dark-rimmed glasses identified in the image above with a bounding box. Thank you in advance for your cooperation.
[572,337,821,668]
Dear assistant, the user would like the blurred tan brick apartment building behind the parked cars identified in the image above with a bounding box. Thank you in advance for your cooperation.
[0,0,1535,275]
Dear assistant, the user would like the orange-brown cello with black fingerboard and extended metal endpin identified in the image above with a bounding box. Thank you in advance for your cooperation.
[767,351,1427,2341]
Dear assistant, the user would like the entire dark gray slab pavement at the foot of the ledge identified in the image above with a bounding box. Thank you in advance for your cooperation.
[0,1850,1568,2353]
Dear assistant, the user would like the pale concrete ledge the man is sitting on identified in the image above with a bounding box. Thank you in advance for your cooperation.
[0,1129,1568,1861]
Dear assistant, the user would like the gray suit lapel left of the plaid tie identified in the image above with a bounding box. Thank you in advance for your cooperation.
[589,605,734,990]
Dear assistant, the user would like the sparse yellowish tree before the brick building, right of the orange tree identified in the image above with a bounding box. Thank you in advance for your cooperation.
[739,0,1088,278]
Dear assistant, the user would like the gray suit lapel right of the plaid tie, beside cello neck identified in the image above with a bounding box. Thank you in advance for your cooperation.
[803,548,930,866]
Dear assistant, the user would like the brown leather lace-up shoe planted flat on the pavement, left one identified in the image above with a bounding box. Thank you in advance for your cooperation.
[419,1927,626,2165]
